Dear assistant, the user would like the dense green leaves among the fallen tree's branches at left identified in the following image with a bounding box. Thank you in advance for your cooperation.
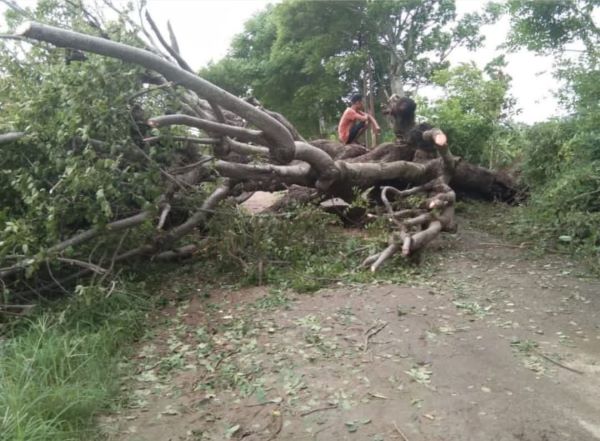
[0,0,199,296]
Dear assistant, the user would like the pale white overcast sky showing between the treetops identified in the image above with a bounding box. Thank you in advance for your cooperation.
[0,0,558,122]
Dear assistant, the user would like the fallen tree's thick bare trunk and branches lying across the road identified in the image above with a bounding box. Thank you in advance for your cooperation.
[0,17,516,294]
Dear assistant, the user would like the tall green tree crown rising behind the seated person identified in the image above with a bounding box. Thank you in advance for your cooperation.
[200,0,493,136]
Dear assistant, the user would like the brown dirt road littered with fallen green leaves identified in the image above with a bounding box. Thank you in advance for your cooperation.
[103,214,600,441]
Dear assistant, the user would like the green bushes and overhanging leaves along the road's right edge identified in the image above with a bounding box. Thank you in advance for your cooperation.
[506,0,600,268]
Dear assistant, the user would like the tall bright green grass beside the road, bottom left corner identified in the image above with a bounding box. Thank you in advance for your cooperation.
[0,287,150,441]
